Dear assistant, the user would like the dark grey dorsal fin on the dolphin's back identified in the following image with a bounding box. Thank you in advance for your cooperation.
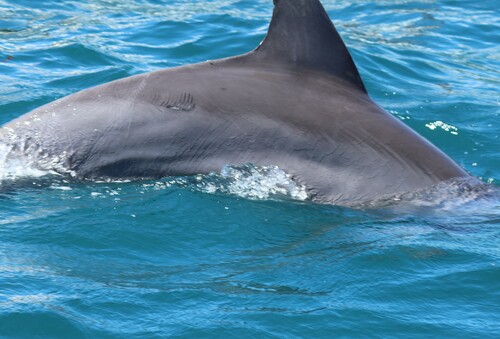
[255,0,366,92]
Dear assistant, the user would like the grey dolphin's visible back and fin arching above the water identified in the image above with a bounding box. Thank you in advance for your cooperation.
[0,0,467,205]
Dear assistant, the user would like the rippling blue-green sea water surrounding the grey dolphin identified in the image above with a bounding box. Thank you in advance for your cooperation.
[0,0,500,338]
